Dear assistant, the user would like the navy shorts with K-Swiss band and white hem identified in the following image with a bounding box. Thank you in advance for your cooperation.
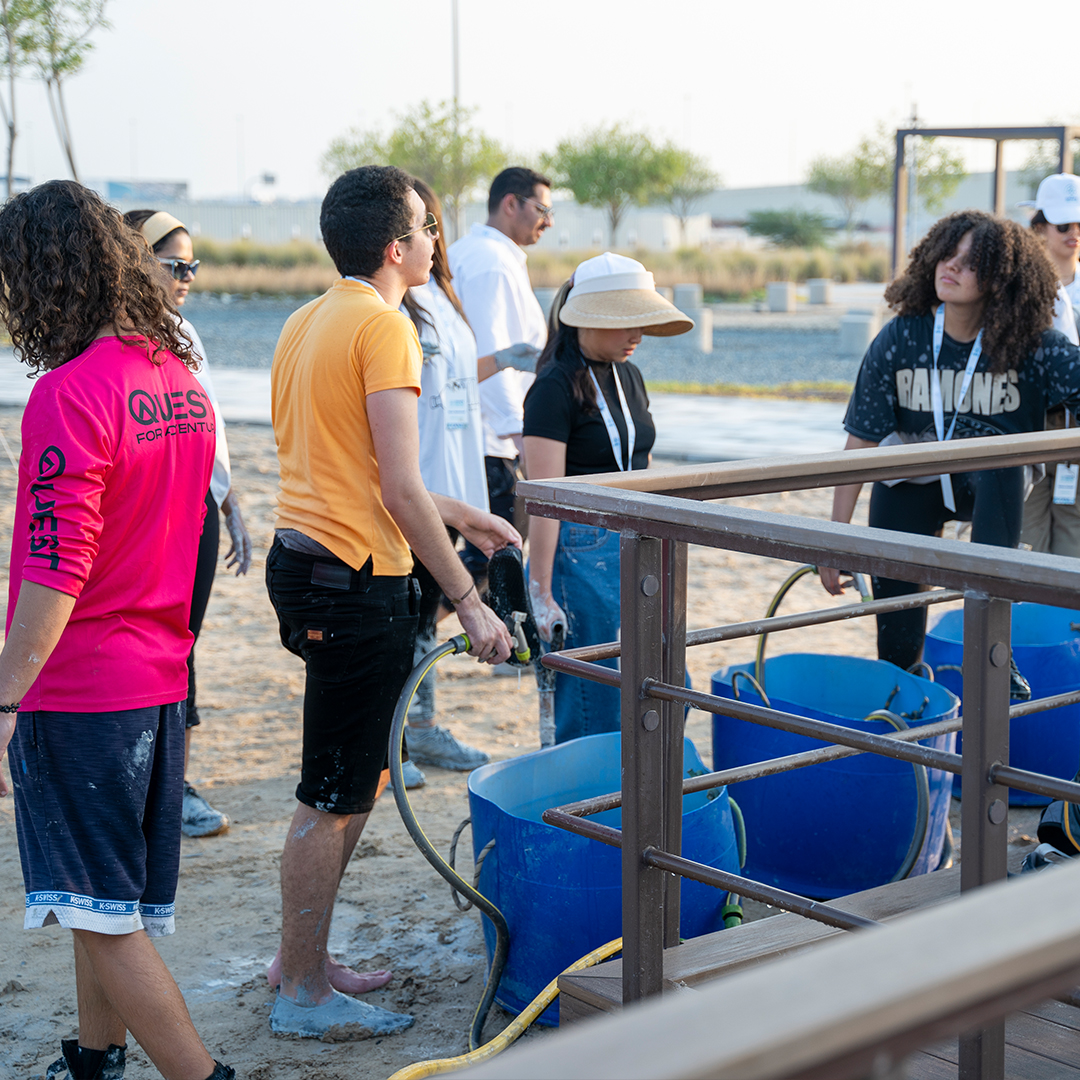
[9,701,184,937]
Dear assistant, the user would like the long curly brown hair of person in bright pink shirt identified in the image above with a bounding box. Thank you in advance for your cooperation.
[0,180,199,372]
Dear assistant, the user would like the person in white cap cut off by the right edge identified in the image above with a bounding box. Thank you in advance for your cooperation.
[1021,173,1080,557]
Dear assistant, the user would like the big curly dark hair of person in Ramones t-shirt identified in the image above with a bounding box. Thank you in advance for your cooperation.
[885,210,1057,375]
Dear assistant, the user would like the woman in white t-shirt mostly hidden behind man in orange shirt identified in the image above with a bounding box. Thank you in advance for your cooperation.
[402,177,537,787]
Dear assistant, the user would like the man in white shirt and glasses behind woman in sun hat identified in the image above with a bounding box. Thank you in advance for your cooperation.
[448,166,553,578]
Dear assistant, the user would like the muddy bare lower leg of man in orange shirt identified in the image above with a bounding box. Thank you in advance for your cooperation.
[281,804,368,1007]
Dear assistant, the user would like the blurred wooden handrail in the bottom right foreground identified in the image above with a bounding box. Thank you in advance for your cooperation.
[459,865,1080,1080]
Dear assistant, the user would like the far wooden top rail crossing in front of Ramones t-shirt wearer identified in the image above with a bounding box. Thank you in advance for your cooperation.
[518,428,1080,499]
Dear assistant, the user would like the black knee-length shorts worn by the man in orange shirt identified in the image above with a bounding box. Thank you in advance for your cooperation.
[267,539,420,814]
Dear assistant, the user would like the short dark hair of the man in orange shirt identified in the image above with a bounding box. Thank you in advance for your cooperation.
[319,165,413,278]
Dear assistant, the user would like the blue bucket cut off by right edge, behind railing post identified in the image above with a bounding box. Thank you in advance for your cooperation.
[922,604,1080,807]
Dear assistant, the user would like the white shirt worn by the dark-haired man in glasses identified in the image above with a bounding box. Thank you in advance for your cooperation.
[448,225,548,459]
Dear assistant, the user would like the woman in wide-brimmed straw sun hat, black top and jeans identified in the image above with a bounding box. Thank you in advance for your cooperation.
[524,252,693,743]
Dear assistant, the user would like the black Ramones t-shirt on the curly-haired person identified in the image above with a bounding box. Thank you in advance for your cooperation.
[843,314,1080,443]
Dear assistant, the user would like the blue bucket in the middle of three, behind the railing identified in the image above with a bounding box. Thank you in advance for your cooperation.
[713,653,958,900]
